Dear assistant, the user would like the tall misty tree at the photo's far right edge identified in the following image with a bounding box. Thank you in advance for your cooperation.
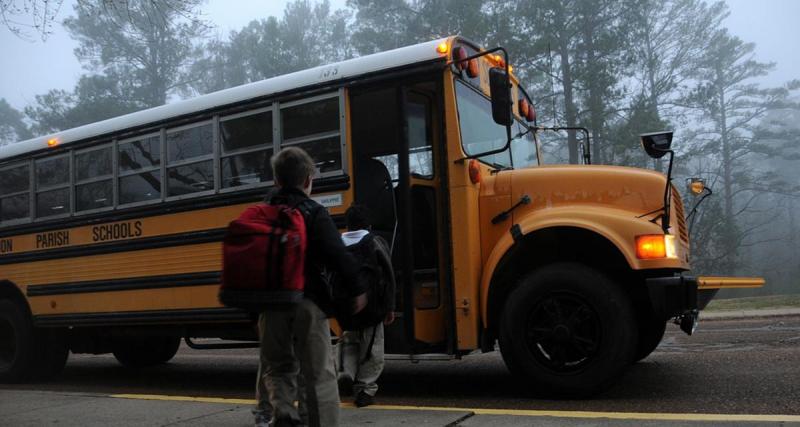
[686,30,800,271]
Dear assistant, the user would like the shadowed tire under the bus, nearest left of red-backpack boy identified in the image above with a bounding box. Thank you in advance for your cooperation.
[113,336,181,368]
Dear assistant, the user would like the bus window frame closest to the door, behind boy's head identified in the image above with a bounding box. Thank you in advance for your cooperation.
[278,87,349,179]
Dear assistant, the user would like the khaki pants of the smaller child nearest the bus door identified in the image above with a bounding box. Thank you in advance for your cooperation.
[339,323,384,396]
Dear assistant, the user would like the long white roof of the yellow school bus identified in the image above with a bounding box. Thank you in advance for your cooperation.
[0,38,450,161]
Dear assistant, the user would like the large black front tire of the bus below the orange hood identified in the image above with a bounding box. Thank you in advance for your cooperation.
[499,263,637,398]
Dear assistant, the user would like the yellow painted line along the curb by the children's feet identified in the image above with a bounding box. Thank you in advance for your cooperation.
[111,394,800,422]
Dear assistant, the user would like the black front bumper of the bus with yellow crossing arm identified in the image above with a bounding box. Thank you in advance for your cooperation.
[646,276,765,335]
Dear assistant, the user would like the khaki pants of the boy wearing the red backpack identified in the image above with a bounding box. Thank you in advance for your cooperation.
[256,299,339,427]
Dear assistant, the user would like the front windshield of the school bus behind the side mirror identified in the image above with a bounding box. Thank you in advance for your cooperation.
[455,80,538,169]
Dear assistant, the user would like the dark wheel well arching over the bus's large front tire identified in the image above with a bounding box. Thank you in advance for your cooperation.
[487,227,644,337]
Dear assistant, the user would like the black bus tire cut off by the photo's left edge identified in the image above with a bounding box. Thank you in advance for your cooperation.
[0,300,36,383]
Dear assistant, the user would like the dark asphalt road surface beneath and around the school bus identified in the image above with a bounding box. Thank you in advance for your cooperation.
[0,316,800,415]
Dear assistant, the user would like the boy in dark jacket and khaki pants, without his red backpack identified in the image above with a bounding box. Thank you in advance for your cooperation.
[256,147,366,427]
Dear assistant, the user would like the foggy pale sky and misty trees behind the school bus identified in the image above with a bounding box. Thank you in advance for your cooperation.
[0,0,800,296]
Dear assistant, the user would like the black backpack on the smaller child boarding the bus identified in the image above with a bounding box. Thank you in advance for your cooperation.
[331,233,395,331]
